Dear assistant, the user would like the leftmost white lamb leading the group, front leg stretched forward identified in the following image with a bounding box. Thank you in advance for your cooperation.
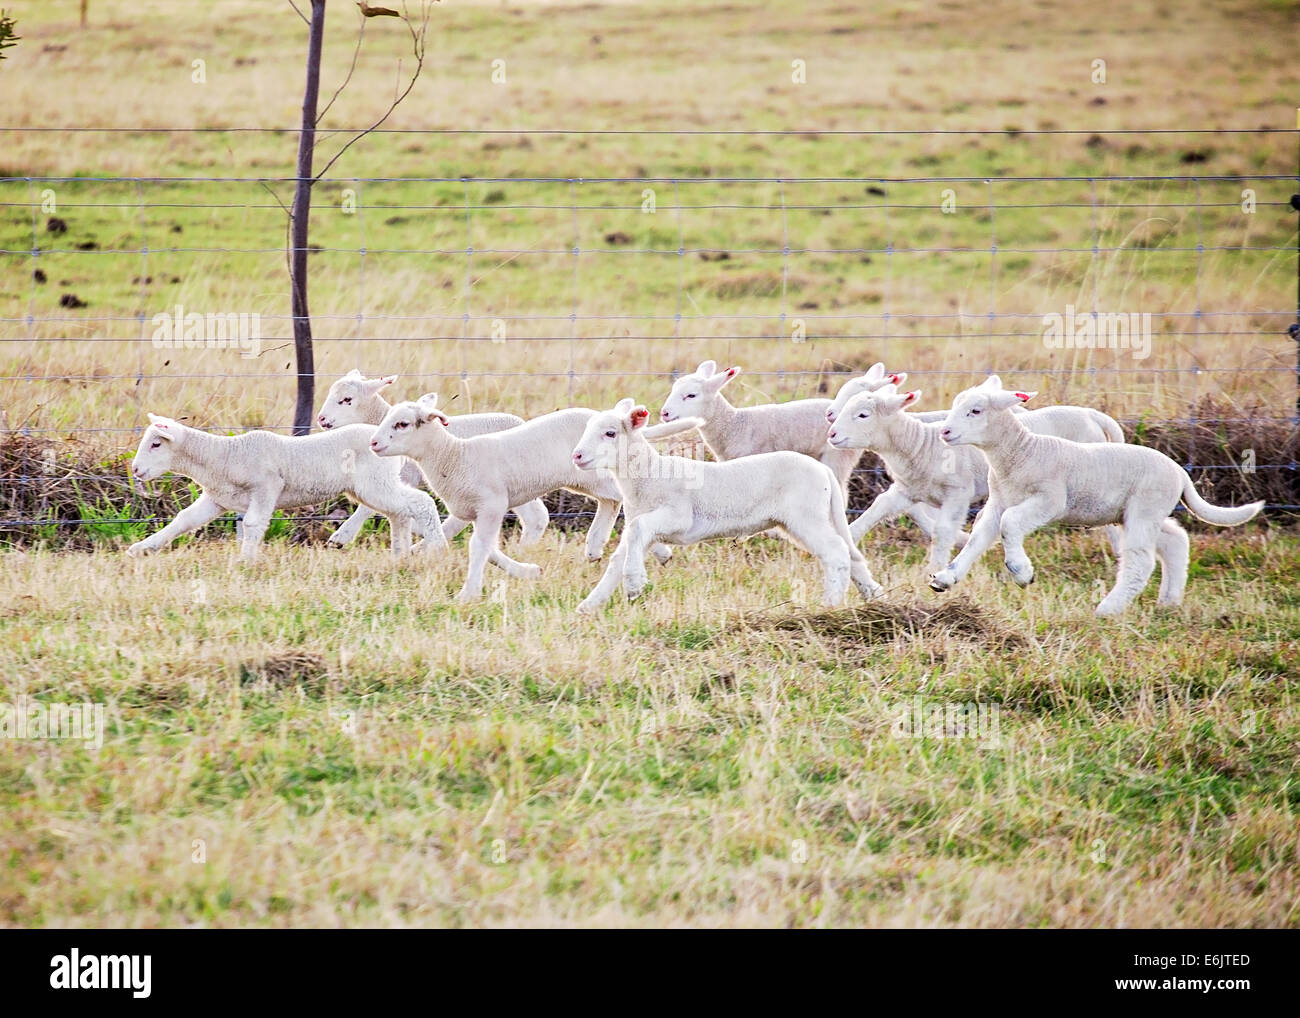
[127,413,447,560]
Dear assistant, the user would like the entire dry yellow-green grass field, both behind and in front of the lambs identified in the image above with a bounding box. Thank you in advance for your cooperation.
[0,0,1300,927]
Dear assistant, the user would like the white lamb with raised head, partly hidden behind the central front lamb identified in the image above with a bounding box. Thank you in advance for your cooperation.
[659,360,862,494]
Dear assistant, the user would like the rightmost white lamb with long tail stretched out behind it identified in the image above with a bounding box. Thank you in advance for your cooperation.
[930,374,1264,616]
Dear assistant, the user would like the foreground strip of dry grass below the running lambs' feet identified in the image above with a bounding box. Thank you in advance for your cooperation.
[0,530,1300,926]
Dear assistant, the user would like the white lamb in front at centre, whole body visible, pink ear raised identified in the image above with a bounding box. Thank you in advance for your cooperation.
[573,399,881,612]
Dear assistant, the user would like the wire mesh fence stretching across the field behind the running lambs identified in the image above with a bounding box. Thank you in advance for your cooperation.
[0,127,1300,530]
